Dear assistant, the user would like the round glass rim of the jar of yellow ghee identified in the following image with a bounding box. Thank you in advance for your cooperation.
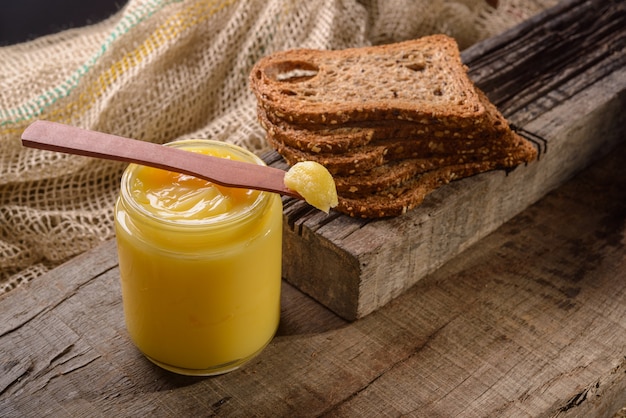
[120,138,271,229]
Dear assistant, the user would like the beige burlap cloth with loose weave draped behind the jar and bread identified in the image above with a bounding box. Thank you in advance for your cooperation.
[0,0,557,294]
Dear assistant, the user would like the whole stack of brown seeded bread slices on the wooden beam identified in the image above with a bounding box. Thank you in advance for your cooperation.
[250,35,537,218]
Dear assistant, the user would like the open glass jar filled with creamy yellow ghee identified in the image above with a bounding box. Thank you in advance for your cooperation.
[115,140,282,375]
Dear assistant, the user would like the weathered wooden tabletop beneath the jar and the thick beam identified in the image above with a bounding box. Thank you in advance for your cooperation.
[0,0,626,417]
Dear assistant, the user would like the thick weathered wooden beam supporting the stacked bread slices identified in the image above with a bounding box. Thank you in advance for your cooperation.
[268,0,626,320]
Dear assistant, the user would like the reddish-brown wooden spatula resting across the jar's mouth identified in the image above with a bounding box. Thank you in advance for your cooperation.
[22,121,302,199]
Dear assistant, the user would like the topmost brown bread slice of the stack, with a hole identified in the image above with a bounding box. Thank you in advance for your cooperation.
[250,35,487,128]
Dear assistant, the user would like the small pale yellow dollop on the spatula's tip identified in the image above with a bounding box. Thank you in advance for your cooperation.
[285,161,339,213]
